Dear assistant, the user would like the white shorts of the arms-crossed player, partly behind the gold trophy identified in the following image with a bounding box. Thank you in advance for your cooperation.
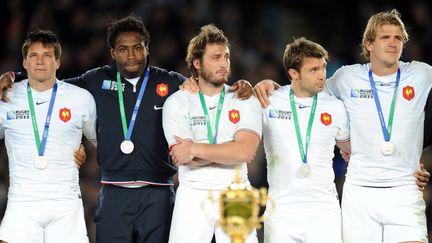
[169,183,258,243]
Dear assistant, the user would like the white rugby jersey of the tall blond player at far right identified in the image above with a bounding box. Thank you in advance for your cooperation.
[326,61,432,187]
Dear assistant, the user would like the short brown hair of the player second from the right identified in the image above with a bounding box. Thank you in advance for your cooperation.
[283,37,328,80]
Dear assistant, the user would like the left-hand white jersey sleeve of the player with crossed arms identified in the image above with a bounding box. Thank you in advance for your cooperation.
[162,91,193,148]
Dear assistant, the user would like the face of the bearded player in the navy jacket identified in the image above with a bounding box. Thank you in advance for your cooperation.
[111,32,148,78]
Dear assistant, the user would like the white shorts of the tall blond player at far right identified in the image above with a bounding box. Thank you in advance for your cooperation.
[342,183,428,243]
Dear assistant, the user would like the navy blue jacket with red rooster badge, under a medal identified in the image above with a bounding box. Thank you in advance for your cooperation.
[65,63,185,184]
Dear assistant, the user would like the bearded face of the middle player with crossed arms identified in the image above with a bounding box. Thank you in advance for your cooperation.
[195,44,231,87]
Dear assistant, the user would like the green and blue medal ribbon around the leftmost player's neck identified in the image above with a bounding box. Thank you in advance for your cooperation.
[27,83,57,156]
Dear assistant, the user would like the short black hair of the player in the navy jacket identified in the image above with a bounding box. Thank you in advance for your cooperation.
[107,15,150,49]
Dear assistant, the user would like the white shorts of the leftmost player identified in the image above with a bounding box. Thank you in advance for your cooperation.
[0,203,89,243]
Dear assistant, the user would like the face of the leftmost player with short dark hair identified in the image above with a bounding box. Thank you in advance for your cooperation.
[23,42,60,82]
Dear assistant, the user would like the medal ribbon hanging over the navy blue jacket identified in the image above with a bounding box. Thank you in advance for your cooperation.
[117,68,150,140]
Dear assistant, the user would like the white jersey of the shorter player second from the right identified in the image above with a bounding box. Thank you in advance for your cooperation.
[263,86,349,211]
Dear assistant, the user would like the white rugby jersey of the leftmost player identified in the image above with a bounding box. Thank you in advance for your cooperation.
[0,80,96,205]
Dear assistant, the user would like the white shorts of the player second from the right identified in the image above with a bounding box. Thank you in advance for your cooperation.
[264,205,342,243]
